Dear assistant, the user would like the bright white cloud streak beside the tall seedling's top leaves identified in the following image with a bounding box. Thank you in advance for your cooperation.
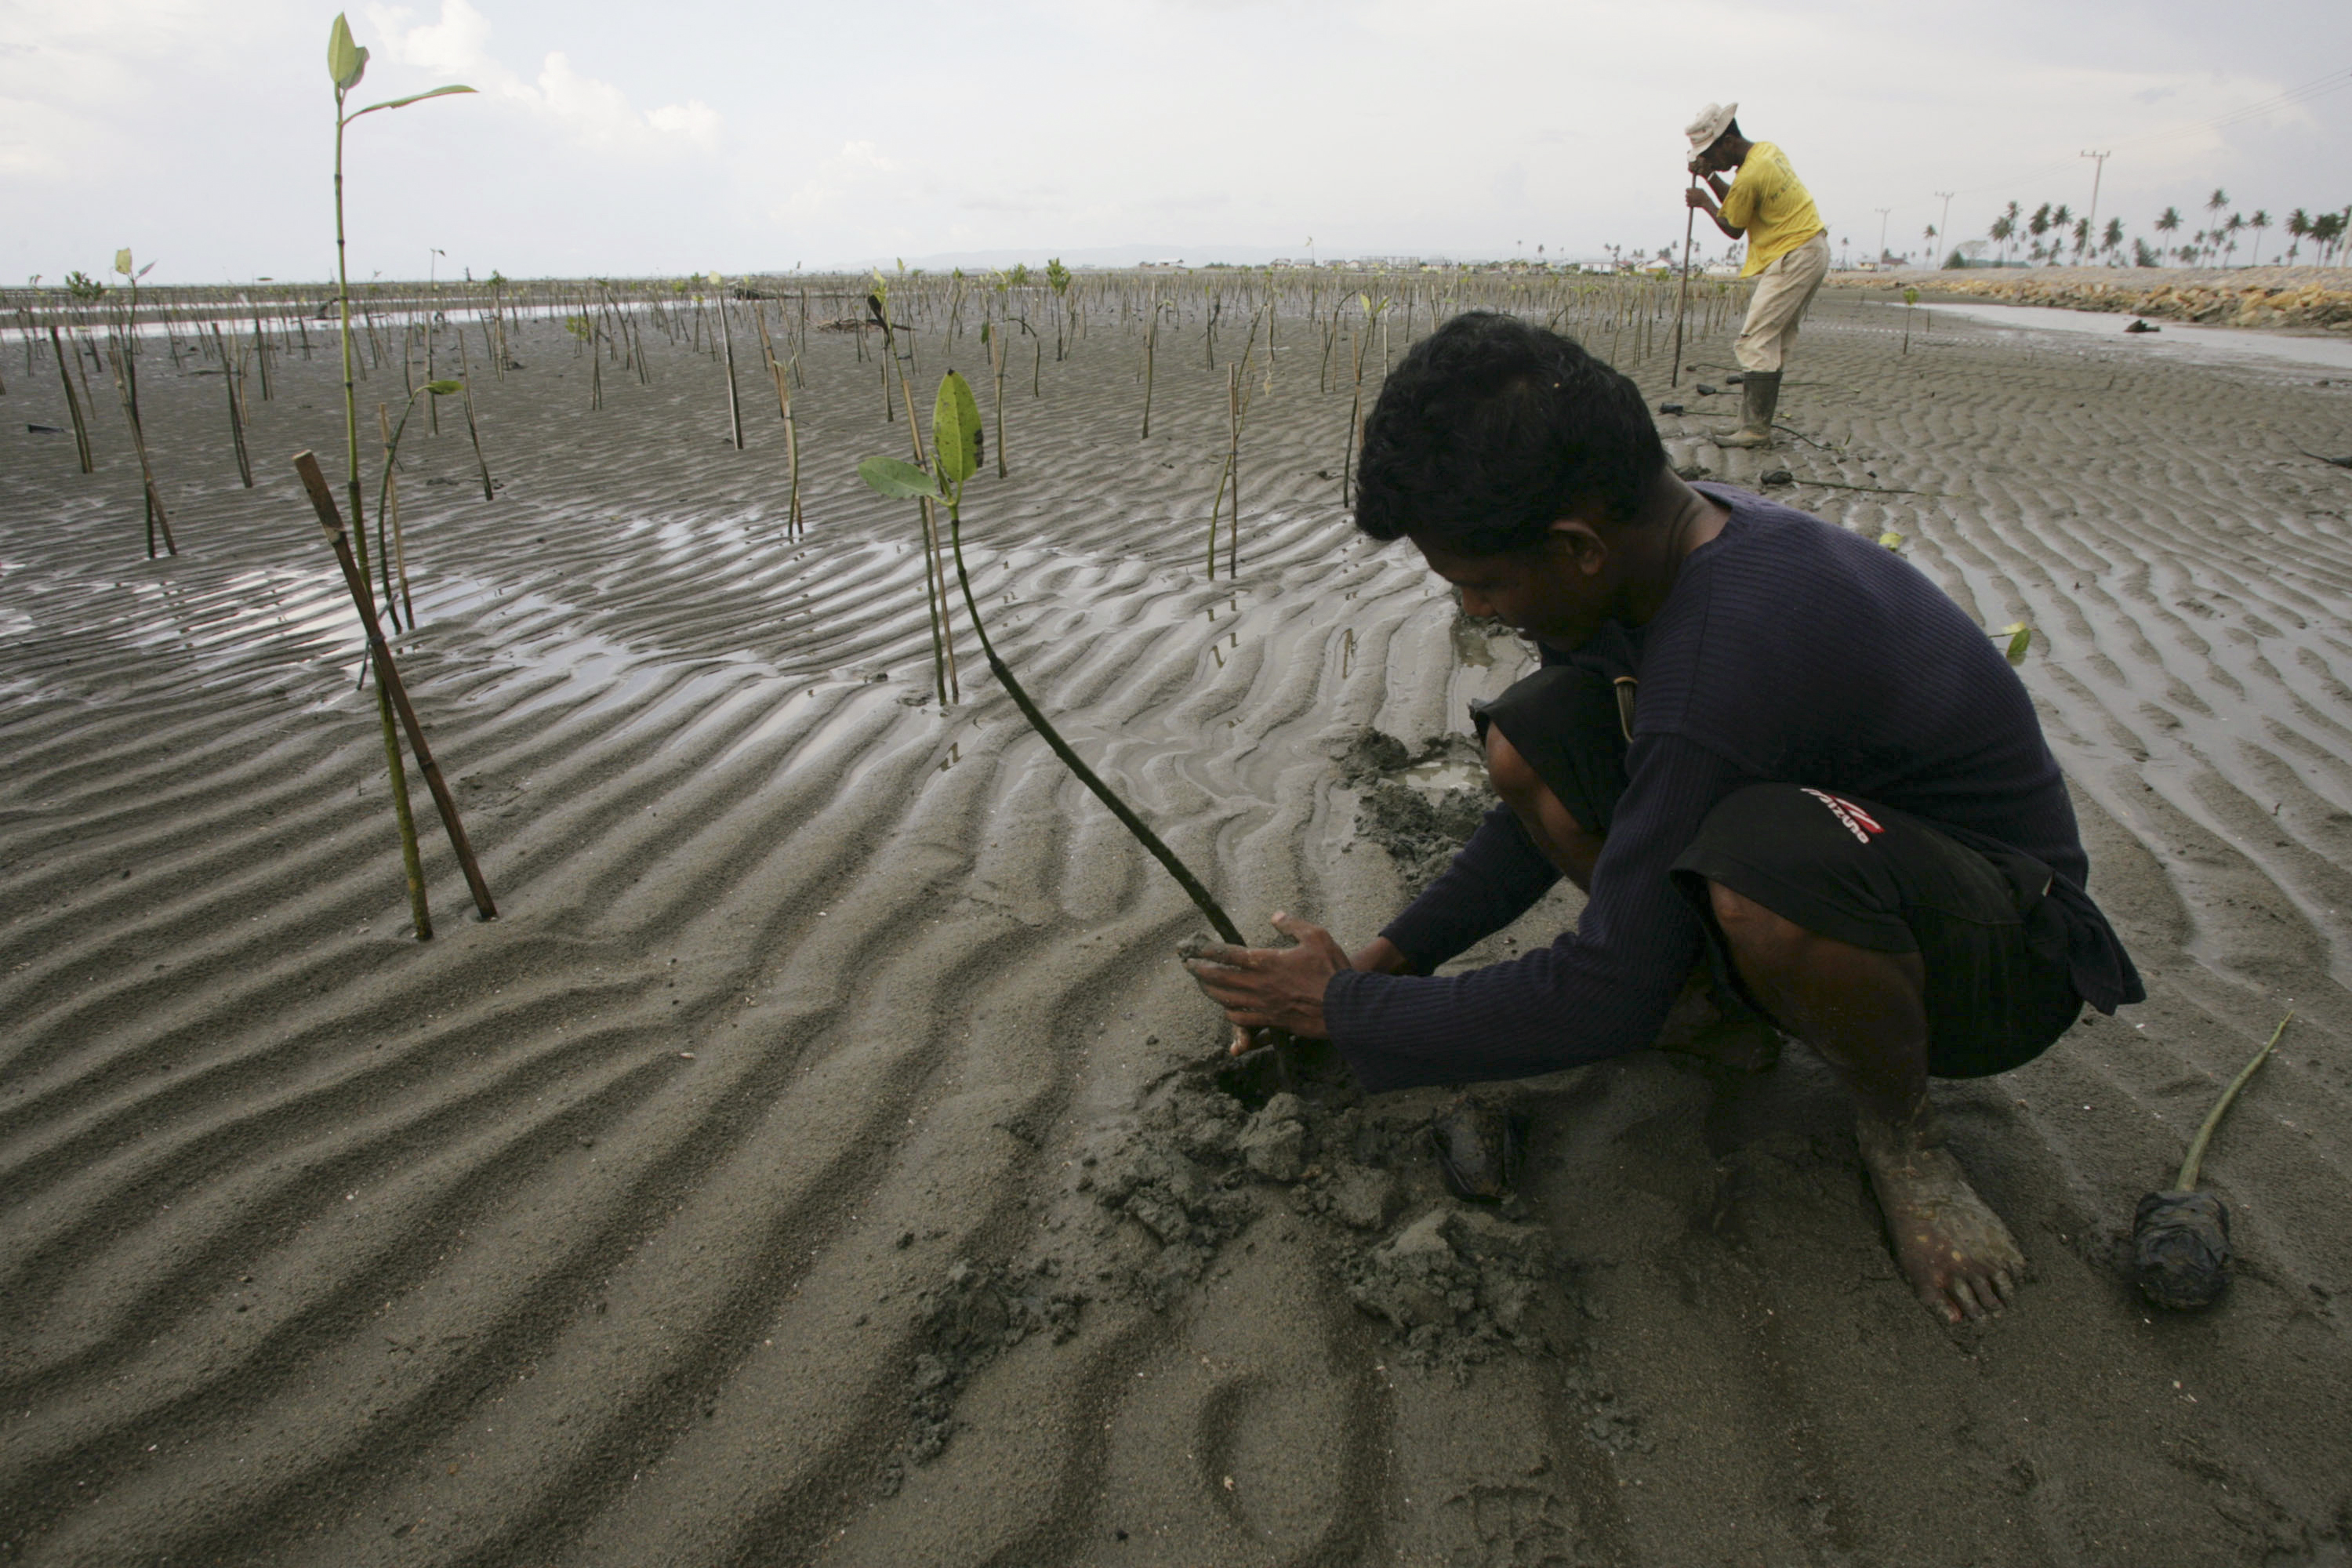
[367,0,722,155]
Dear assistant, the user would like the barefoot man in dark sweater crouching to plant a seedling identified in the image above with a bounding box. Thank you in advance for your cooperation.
[1192,313,2143,1321]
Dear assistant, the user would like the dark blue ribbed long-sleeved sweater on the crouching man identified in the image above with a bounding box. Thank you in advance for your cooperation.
[1324,487,2145,1091]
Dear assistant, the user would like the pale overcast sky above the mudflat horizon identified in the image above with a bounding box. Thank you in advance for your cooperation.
[0,0,2352,282]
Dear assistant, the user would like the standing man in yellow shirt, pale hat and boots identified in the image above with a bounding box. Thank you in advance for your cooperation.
[1684,103,1830,447]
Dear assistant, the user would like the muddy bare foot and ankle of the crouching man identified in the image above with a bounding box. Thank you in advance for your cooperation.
[1856,1112,2025,1323]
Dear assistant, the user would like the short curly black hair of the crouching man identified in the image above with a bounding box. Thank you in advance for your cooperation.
[1355,310,1665,555]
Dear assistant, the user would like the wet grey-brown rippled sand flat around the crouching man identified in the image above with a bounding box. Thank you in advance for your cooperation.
[0,294,2352,1568]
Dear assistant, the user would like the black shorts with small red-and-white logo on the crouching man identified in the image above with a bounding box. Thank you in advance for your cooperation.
[1475,666,2082,1079]
